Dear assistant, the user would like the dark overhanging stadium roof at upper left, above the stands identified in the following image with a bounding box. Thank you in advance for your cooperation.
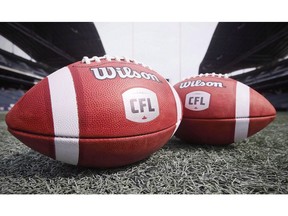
[0,22,105,73]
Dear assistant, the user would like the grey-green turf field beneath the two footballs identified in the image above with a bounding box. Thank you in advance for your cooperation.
[0,112,288,194]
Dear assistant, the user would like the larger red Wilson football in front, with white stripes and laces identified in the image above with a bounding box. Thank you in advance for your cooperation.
[6,55,182,168]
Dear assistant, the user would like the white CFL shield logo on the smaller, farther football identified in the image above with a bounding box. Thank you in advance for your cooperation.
[185,91,210,111]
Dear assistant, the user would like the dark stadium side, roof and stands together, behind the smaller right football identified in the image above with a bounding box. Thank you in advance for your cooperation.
[199,22,288,110]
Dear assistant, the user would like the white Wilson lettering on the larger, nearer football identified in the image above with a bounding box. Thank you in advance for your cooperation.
[90,67,161,82]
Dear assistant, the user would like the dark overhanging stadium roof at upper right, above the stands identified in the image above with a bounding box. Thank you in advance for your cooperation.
[199,22,288,73]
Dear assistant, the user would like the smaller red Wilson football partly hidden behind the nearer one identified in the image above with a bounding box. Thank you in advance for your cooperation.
[174,73,276,145]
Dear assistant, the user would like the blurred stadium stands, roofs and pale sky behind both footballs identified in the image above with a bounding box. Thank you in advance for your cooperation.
[0,22,288,111]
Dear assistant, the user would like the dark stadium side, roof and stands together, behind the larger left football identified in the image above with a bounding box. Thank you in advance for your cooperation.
[0,22,105,111]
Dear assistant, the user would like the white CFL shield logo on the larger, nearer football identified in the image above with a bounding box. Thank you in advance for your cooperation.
[122,88,159,123]
